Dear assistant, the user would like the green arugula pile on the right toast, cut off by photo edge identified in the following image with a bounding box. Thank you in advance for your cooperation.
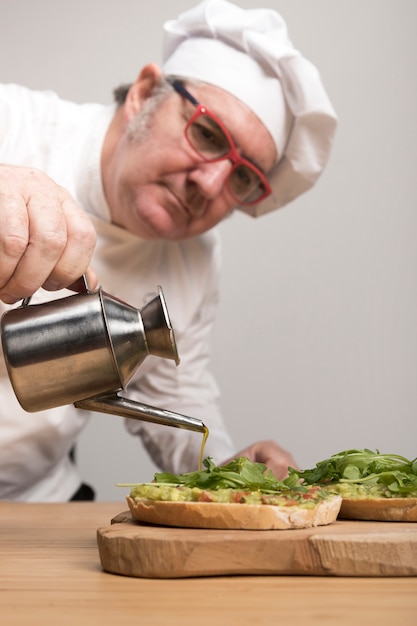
[284,448,417,497]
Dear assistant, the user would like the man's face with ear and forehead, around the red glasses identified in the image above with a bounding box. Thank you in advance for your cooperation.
[102,65,277,240]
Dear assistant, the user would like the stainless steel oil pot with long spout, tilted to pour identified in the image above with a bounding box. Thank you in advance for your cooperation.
[1,277,205,432]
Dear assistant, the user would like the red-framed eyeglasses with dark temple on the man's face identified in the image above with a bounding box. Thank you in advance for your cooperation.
[171,80,271,205]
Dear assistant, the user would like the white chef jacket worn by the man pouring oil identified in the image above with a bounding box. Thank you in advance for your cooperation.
[0,84,235,502]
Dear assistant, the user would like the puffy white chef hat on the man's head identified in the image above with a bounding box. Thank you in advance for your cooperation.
[163,0,337,217]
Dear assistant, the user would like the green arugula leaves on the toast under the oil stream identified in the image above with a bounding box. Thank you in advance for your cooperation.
[154,457,290,491]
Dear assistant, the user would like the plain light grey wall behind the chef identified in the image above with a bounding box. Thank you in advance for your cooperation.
[0,0,417,500]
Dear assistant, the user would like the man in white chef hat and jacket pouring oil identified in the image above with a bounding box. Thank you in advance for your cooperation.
[0,0,336,502]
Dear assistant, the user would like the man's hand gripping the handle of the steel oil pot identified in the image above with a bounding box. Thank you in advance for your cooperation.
[0,165,97,304]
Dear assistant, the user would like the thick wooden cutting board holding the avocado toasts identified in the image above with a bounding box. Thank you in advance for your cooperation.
[97,512,417,578]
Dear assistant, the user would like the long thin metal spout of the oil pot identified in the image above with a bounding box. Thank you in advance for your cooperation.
[74,393,207,433]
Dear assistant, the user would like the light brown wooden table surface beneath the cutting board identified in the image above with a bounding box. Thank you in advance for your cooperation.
[0,502,417,626]
